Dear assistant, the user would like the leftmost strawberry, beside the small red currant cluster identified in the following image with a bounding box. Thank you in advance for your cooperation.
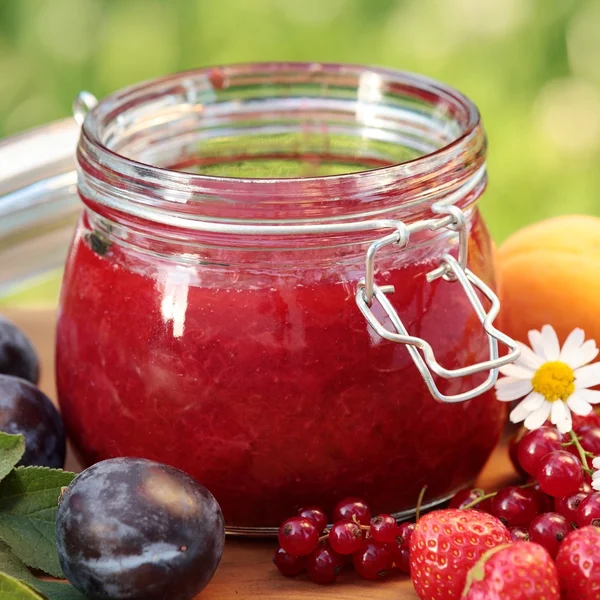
[410,509,511,600]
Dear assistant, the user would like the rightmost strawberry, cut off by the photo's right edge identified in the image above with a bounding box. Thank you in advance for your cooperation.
[556,525,600,600]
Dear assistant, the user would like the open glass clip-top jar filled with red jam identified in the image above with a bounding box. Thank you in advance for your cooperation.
[57,63,517,534]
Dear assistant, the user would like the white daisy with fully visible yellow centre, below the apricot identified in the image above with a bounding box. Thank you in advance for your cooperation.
[496,325,600,434]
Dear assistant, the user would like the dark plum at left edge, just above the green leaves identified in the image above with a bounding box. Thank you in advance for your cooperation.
[0,375,66,469]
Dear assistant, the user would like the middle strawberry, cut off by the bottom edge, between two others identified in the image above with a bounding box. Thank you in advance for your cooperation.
[461,542,560,600]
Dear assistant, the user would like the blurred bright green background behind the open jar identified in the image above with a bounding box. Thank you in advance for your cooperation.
[0,0,600,241]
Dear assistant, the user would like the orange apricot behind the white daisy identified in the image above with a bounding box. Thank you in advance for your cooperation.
[496,215,600,343]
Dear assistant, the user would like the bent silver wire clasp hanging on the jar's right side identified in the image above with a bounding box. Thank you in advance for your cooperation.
[356,204,520,403]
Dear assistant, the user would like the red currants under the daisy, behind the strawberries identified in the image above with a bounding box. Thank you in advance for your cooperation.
[450,423,600,557]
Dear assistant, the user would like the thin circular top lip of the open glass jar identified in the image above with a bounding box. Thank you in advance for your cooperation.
[81,62,480,185]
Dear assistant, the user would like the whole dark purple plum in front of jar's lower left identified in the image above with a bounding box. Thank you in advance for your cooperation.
[56,458,225,600]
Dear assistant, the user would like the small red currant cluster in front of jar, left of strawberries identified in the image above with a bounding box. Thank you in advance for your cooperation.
[273,498,415,583]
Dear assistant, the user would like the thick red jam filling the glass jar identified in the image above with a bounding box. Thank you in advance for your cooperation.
[57,209,503,527]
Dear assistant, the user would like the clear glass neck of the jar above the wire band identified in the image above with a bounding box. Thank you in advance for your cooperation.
[77,62,486,233]
